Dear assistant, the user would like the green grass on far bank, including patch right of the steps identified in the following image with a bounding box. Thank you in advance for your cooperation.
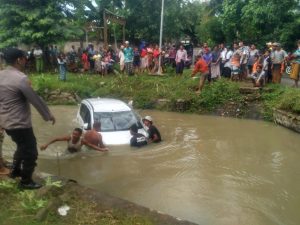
[30,70,300,120]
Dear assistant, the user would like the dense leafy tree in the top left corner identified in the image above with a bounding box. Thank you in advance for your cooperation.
[0,0,82,48]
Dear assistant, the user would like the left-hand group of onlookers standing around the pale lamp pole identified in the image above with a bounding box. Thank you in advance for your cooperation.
[0,41,192,78]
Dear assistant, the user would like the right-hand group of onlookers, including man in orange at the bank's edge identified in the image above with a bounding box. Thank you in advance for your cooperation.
[192,41,300,92]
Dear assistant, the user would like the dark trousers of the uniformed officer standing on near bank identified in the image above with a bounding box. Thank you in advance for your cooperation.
[5,128,38,183]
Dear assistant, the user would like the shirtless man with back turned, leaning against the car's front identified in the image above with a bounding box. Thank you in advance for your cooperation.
[83,122,108,151]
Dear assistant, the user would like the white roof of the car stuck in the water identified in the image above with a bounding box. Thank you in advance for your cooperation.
[82,98,131,112]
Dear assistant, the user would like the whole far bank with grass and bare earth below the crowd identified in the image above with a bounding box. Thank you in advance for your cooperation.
[30,70,300,128]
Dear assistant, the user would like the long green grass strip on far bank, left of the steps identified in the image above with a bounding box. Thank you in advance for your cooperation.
[30,70,244,112]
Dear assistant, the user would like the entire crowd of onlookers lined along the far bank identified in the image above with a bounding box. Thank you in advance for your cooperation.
[1,41,299,86]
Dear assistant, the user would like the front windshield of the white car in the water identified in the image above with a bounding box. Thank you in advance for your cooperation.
[94,111,142,132]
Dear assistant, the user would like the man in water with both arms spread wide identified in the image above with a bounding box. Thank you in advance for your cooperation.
[40,128,107,153]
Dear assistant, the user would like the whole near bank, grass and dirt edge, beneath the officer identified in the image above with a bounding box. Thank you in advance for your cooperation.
[0,173,194,225]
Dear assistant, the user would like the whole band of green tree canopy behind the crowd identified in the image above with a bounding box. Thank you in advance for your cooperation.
[0,0,300,48]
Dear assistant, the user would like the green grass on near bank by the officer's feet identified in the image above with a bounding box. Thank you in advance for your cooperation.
[0,179,155,225]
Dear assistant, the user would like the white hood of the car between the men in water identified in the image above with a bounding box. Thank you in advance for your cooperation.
[101,129,147,145]
